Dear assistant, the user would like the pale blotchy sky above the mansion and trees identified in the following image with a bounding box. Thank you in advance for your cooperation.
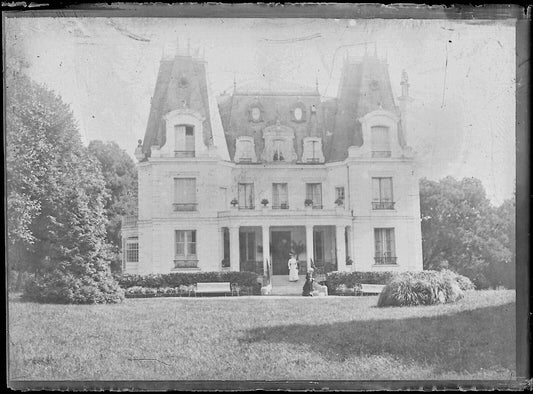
[5,17,516,204]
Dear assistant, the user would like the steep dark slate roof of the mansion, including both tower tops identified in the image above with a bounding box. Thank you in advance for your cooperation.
[143,55,405,162]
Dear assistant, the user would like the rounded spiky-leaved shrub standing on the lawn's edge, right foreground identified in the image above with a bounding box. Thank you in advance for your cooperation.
[378,271,464,307]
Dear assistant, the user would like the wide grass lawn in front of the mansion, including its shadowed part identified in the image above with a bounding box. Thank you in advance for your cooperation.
[9,291,515,380]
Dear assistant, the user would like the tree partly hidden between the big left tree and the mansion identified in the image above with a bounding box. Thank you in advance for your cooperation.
[89,141,137,271]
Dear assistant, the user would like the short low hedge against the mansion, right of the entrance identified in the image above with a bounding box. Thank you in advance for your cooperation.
[326,271,394,294]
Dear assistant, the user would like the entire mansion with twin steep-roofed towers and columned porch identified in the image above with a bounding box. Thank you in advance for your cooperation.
[122,45,422,275]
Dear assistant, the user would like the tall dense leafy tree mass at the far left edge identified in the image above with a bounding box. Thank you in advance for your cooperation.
[6,73,121,302]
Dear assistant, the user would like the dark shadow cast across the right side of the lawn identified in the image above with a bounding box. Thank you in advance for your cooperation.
[240,302,516,373]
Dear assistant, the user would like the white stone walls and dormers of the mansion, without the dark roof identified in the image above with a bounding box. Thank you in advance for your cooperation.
[122,50,422,274]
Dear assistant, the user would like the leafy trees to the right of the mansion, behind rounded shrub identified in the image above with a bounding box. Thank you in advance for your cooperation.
[420,177,514,288]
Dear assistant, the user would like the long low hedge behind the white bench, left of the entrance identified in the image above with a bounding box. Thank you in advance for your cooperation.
[116,271,260,294]
